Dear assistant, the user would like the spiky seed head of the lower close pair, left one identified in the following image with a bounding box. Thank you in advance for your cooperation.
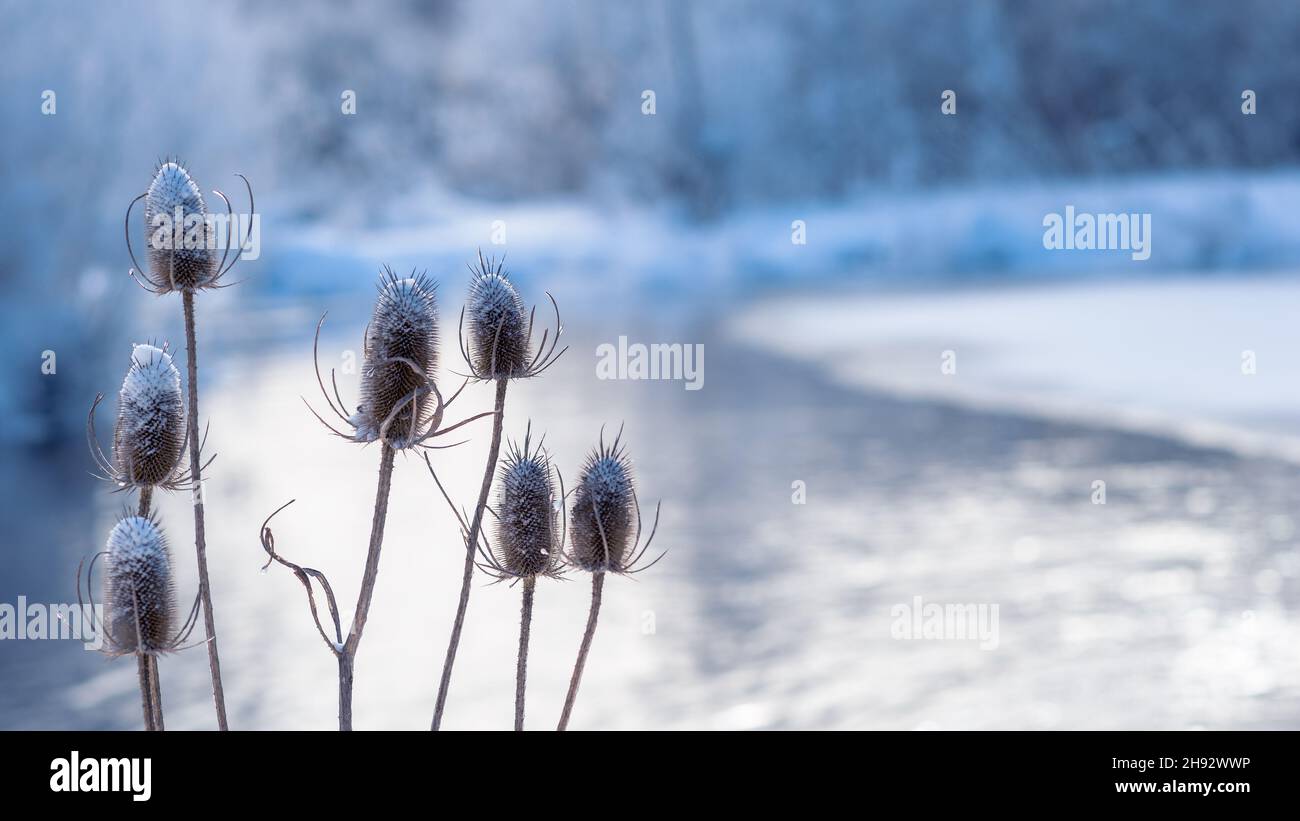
[494,438,563,578]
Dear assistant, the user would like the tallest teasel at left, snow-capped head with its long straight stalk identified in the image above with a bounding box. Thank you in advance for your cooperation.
[126,160,254,730]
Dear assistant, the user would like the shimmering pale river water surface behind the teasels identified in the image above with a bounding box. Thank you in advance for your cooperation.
[0,305,1300,729]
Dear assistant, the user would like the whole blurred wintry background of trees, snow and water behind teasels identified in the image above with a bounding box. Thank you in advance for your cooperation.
[0,0,1300,729]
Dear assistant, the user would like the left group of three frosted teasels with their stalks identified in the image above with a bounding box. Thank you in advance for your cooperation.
[77,160,254,730]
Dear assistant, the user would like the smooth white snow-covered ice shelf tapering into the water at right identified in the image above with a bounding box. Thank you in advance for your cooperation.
[729,278,1300,461]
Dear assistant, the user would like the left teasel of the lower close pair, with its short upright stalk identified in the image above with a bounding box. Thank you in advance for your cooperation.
[425,423,566,730]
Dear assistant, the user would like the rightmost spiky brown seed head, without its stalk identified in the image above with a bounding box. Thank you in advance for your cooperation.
[569,439,636,573]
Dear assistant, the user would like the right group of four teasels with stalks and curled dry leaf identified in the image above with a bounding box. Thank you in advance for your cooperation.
[261,255,658,730]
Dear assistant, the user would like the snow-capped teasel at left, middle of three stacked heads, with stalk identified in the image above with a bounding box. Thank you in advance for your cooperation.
[86,344,202,730]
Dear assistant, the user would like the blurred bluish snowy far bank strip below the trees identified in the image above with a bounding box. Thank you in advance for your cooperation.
[261,171,1300,303]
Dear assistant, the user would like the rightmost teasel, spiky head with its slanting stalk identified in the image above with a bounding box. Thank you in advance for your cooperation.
[556,429,664,730]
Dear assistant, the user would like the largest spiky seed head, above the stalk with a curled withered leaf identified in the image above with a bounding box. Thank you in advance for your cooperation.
[351,268,438,448]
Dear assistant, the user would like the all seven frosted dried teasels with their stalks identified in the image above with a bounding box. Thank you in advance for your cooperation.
[78,161,662,730]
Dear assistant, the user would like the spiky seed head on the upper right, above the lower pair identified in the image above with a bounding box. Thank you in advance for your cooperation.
[465,256,529,379]
